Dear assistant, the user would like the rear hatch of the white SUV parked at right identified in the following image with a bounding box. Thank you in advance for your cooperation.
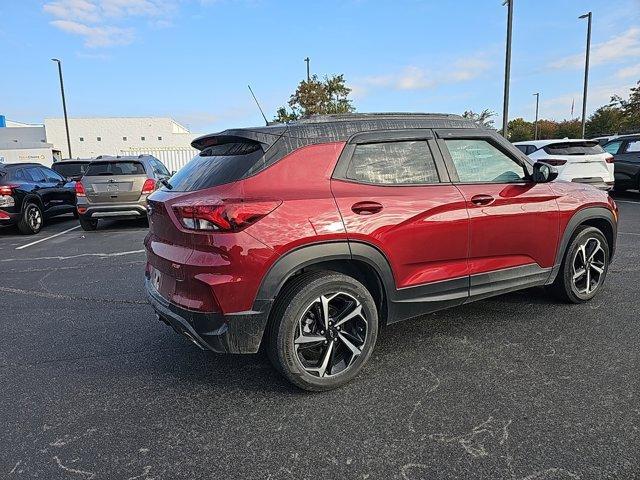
[541,140,613,181]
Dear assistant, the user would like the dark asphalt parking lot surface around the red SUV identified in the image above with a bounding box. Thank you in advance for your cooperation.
[0,193,640,480]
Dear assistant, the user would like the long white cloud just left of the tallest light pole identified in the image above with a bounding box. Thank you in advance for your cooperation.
[350,56,491,97]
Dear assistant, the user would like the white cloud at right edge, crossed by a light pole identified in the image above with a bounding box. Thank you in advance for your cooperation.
[549,27,640,69]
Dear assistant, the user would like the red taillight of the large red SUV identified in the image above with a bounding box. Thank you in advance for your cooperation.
[173,200,282,232]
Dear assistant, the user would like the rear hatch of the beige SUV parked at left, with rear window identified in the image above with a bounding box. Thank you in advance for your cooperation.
[82,160,147,203]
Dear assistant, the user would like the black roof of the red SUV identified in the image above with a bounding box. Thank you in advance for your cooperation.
[191,113,478,150]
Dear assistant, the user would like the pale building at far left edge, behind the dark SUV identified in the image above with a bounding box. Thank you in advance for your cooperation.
[0,115,60,167]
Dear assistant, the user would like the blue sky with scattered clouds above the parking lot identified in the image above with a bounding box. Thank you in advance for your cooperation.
[0,0,640,132]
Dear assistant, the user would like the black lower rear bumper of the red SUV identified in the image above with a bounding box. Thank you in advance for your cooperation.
[145,276,271,353]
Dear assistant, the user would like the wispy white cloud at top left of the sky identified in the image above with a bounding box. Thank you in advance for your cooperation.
[43,0,180,48]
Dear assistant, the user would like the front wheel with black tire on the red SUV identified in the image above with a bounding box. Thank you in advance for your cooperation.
[550,225,610,303]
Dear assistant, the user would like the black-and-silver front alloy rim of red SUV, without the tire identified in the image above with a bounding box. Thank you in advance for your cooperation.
[572,237,607,295]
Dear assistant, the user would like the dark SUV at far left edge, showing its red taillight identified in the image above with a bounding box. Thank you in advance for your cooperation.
[0,163,76,234]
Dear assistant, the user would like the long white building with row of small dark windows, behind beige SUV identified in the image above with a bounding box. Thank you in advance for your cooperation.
[44,117,199,170]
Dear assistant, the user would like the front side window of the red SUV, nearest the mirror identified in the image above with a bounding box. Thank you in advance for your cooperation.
[445,140,526,183]
